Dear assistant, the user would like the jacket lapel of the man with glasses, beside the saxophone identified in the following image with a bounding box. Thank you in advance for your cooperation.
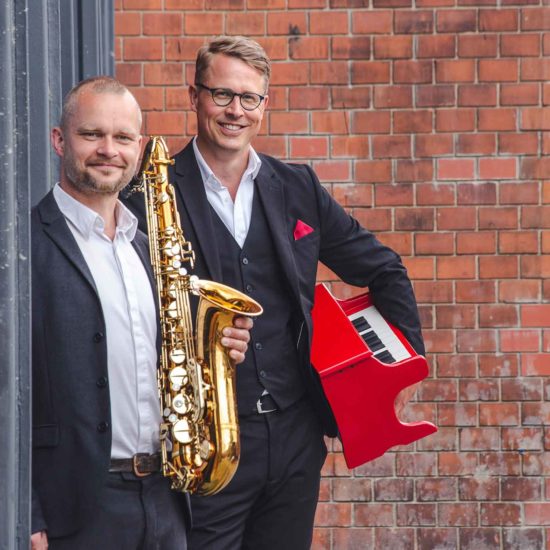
[171,142,222,281]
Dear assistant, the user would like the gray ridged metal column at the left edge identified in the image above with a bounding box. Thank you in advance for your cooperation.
[0,0,114,550]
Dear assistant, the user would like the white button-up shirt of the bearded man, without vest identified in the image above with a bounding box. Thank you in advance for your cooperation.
[53,184,161,458]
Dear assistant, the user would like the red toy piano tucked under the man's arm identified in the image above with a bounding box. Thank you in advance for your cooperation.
[311,284,437,468]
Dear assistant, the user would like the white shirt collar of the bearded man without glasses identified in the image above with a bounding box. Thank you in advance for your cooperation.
[53,183,138,241]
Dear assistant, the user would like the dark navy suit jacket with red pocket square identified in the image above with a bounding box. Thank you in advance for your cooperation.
[127,143,424,435]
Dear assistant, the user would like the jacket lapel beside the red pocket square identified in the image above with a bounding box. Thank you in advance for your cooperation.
[255,161,300,302]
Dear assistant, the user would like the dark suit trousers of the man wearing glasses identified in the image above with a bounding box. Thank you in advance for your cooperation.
[188,399,327,550]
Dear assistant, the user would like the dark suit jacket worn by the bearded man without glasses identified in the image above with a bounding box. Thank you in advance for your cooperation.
[31,191,192,537]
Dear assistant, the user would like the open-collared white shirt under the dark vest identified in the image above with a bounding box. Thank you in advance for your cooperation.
[193,137,262,248]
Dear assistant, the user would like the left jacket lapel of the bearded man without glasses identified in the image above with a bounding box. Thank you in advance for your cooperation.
[37,191,97,295]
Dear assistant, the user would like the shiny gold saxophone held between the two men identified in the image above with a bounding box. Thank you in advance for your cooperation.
[138,136,262,495]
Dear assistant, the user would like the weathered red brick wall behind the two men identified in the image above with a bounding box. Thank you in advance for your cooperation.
[116,0,550,550]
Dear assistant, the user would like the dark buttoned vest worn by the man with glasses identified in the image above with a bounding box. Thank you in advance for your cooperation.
[211,191,304,415]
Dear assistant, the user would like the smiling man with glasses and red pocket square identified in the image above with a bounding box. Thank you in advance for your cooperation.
[125,37,424,550]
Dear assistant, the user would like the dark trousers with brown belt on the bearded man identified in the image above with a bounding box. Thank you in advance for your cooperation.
[49,473,187,550]
